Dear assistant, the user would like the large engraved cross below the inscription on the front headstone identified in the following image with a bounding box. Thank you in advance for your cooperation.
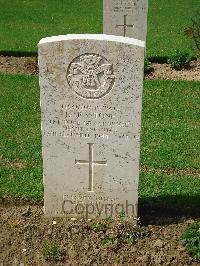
[75,143,107,192]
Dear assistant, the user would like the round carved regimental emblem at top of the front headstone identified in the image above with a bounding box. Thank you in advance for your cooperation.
[67,54,115,99]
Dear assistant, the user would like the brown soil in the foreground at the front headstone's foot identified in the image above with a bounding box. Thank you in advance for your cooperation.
[0,202,199,266]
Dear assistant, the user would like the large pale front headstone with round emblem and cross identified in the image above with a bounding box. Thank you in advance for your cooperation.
[38,35,144,218]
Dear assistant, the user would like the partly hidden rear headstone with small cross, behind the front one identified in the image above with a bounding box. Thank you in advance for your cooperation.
[103,0,148,41]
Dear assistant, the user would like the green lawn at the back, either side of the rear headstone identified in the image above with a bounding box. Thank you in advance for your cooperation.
[0,0,200,57]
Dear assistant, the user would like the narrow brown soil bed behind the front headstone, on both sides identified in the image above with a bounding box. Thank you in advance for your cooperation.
[0,56,200,81]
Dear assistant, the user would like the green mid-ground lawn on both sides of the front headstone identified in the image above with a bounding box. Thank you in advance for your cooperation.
[0,74,200,210]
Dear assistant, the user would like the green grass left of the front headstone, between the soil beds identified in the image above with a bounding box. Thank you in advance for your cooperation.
[0,74,43,198]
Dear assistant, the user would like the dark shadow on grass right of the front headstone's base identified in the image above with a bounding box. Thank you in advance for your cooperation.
[139,195,200,225]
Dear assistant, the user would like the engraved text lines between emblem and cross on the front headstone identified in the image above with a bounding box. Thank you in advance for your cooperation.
[43,103,133,141]
